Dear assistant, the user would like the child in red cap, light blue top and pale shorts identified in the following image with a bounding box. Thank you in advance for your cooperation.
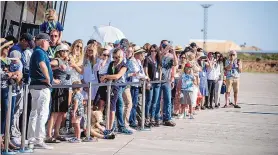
[176,63,197,119]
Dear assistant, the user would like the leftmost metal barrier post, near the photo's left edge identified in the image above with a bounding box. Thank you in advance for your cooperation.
[3,85,16,155]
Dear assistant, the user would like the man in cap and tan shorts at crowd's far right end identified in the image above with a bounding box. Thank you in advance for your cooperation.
[224,50,242,108]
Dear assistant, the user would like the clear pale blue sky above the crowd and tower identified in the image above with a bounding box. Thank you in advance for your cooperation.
[63,1,278,50]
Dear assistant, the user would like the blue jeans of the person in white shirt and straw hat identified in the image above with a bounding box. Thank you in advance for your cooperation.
[129,86,139,126]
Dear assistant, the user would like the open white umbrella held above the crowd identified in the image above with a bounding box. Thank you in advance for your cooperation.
[91,26,125,44]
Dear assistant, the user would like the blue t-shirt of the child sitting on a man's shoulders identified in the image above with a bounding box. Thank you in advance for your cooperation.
[40,21,64,34]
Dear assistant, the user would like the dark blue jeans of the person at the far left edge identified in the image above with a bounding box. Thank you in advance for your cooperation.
[1,87,16,134]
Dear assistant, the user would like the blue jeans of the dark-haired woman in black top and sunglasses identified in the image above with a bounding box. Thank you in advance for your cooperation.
[145,83,161,119]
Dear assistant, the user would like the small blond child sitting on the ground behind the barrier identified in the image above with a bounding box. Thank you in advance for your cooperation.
[90,106,115,139]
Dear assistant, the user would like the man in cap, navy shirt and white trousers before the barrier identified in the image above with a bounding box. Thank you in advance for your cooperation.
[27,33,53,149]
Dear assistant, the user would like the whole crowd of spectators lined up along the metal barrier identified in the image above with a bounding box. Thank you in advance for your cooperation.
[1,9,242,153]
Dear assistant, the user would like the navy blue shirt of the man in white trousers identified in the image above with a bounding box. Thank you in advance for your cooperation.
[30,46,53,85]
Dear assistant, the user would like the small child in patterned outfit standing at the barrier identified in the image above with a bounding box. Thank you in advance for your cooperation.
[69,81,84,143]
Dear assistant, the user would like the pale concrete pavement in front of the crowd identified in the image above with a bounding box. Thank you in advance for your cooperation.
[25,73,278,155]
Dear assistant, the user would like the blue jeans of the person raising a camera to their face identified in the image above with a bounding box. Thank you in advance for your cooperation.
[155,83,172,121]
